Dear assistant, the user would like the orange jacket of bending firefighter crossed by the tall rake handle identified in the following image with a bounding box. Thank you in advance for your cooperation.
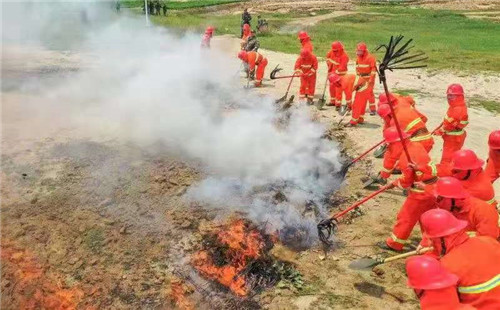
[380,141,437,198]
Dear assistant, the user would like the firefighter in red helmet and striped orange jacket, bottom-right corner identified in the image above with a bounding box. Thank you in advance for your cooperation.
[420,209,500,310]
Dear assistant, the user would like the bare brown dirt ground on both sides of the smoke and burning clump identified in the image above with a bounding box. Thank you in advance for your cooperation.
[0,4,500,309]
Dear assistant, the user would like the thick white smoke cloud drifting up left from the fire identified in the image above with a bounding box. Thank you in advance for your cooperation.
[4,1,341,245]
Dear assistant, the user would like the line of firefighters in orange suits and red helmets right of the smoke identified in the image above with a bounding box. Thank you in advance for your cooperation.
[201,23,500,310]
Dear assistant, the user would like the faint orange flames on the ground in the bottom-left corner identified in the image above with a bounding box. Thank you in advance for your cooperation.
[0,240,83,310]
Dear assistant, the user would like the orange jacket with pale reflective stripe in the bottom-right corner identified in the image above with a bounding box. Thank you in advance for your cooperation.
[441,236,500,310]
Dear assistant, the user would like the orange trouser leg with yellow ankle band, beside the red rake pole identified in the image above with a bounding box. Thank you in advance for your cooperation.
[386,194,436,251]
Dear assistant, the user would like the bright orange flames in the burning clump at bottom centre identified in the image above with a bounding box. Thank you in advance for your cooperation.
[191,219,265,296]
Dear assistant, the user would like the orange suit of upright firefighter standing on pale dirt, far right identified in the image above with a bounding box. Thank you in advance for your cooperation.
[436,96,469,164]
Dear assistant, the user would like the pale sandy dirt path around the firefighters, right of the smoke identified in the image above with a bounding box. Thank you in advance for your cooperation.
[213,37,500,309]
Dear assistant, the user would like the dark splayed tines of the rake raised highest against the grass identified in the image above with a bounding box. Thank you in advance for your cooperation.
[376,35,429,81]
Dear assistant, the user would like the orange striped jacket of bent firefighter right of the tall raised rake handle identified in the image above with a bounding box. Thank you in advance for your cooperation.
[390,102,434,152]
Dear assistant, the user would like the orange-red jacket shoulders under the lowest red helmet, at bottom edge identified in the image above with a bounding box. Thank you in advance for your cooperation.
[419,286,476,310]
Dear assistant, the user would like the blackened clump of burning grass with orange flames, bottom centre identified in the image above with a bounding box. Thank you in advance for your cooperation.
[191,219,300,297]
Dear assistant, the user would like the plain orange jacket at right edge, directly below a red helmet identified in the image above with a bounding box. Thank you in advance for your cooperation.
[458,169,496,206]
